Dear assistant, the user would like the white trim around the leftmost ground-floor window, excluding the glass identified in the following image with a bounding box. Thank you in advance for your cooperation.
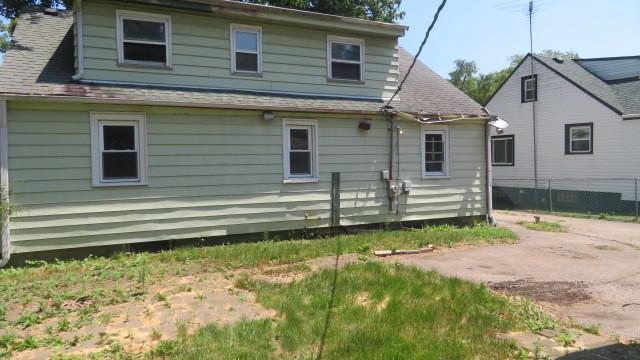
[90,113,148,187]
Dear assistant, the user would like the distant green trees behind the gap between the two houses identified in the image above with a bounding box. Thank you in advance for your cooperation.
[449,50,580,104]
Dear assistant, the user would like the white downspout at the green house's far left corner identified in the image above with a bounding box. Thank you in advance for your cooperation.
[0,100,11,267]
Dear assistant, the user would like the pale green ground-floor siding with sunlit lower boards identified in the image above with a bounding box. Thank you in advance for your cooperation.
[8,102,486,252]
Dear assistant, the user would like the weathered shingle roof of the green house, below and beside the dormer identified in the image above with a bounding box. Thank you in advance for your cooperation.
[0,11,484,116]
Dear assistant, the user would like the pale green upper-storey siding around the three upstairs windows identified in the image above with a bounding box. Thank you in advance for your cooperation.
[83,1,398,98]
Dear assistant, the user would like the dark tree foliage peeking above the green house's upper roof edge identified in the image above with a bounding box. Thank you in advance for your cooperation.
[237,0,404,22]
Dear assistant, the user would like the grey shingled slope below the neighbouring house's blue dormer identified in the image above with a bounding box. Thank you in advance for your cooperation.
[536,55,640,115]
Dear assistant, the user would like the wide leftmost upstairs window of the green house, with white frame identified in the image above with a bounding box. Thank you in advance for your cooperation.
[117,10,171,67]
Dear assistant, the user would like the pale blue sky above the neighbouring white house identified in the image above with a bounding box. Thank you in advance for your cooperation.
[400,0,640,78]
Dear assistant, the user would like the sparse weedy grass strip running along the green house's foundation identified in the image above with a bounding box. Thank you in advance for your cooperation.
[0,225,517,358]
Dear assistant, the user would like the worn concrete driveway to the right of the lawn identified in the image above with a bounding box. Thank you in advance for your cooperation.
[402,211,640,340]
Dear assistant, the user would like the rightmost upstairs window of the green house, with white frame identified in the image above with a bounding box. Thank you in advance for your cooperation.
[327,37,364,82]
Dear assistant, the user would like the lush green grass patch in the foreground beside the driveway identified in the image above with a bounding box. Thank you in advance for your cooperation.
[152,262,555,359]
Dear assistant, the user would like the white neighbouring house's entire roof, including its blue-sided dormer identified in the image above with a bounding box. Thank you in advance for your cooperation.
[535,55,640,115]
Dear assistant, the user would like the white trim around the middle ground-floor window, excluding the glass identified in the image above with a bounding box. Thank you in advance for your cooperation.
[282,119,320,184]
